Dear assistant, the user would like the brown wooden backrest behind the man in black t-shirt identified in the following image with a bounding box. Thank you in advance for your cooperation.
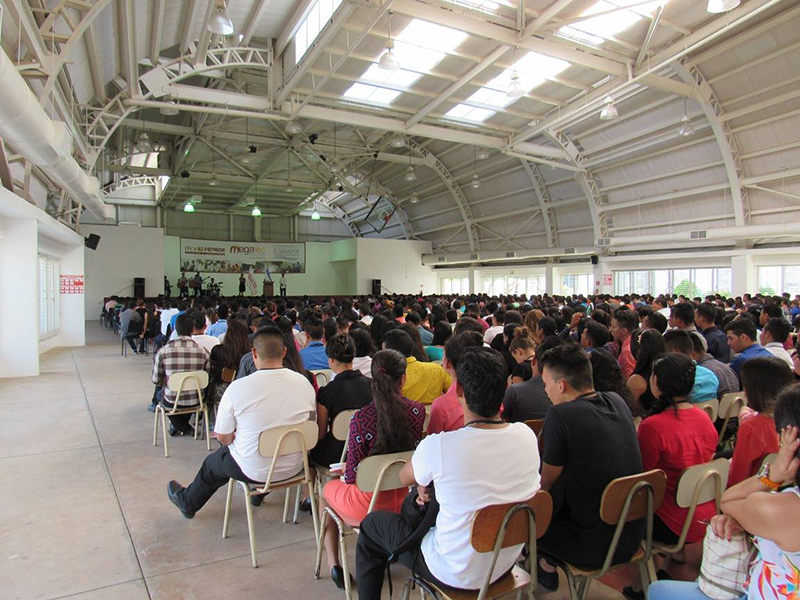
[600,469,667,525]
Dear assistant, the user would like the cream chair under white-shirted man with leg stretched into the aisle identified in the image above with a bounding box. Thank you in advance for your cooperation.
[222,421,319,569]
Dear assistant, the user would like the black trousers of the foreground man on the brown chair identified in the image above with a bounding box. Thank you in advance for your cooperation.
[356,511,446,600]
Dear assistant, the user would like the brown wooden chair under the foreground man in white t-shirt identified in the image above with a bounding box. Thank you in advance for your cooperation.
[403,490,553,600]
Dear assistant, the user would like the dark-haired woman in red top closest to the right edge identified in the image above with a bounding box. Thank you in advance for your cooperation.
[728,356,794,487]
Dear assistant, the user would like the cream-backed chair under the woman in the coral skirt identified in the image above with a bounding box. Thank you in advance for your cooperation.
[314,451,414,600]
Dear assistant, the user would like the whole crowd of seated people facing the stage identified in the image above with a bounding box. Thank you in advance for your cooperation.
[104,295,800,598]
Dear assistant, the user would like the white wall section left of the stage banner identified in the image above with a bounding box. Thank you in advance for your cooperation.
[81,225,164,320]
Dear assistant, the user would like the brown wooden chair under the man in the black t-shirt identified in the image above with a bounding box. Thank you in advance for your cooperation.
[543,469,667,600]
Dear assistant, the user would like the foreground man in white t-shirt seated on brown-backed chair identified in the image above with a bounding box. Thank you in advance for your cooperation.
[356,348,540,598]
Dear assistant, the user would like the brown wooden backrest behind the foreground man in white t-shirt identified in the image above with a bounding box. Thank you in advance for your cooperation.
[470,490,553,552]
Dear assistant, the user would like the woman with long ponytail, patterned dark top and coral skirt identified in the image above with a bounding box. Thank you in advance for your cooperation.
[320,350,425,589]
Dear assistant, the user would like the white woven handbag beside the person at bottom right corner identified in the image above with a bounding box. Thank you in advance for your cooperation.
[697,525,755,600]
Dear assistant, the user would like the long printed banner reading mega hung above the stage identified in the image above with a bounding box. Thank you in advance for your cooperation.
[181,238,306,273]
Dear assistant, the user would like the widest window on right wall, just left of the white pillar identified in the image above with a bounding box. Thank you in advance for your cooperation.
[614,267,731,298]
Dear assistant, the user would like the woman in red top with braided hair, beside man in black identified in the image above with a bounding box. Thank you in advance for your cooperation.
[623,352,718,598]
